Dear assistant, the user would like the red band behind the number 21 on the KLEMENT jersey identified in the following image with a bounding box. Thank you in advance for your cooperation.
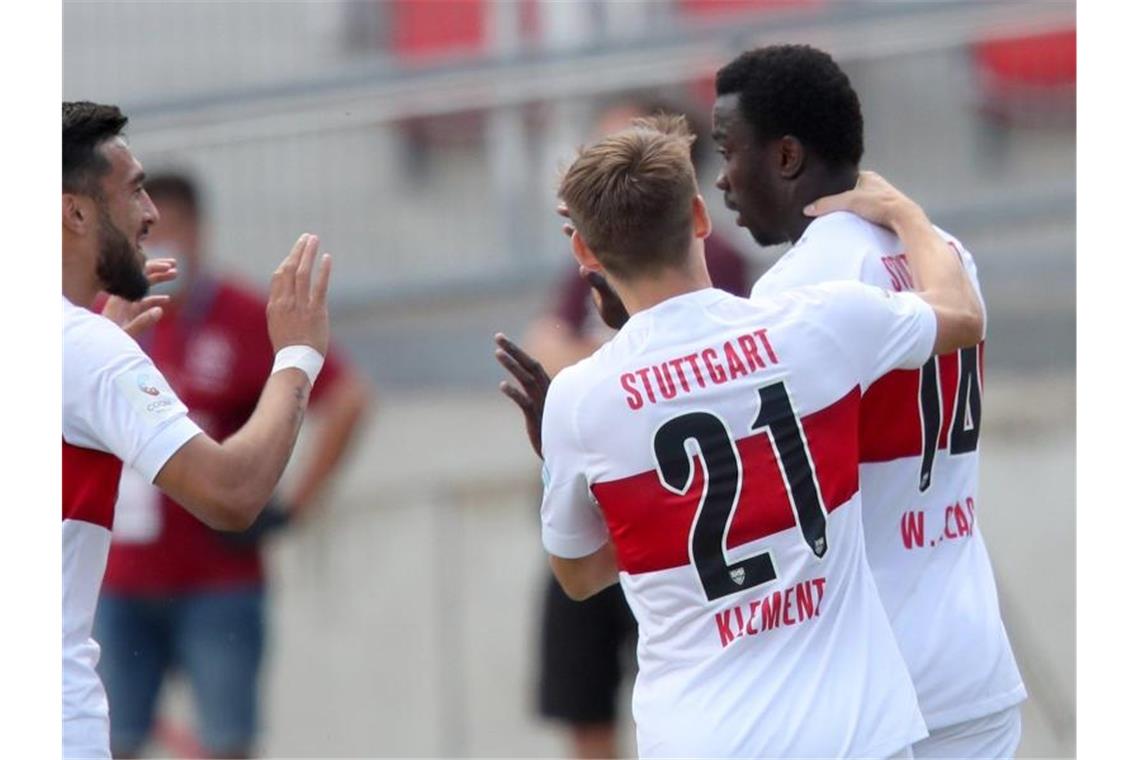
[592,387,860,574]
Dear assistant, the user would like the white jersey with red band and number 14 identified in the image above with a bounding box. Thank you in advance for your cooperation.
[752,212,1026,730]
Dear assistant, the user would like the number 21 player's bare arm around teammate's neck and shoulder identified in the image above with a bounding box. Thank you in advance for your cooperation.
[804,171,985,353]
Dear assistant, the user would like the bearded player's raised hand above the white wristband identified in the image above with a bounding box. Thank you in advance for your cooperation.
[266,232,333,353]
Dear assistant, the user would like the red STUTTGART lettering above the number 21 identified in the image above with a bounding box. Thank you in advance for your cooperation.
[619,329,780,411]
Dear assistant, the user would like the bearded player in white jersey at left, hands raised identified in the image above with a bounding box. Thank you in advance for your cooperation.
[62,103,332,758]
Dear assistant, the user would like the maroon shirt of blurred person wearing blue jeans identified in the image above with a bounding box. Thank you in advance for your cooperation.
[104,279,344,594]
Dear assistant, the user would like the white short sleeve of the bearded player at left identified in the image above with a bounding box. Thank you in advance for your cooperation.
[63,316,202,482]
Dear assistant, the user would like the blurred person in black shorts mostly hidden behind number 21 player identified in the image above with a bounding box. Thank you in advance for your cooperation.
[524,100,755,758]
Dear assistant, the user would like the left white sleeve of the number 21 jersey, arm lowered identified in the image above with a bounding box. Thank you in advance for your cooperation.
[542,368,609,559]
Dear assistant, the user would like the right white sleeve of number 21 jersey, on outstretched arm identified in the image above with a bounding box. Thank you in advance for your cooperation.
[819,283,938,387]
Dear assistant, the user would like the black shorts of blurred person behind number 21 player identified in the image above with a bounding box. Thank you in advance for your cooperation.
[538,575,637,725]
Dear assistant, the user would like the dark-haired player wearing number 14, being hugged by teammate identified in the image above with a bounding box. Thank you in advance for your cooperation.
[713,46,1026,758]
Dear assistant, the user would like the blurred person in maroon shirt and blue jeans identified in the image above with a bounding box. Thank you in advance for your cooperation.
[95,174,369,758]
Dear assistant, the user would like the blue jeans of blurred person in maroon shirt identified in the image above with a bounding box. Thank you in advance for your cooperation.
[95,587,264,757]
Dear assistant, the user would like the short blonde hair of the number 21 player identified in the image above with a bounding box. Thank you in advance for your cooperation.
[559,114,698,278]
